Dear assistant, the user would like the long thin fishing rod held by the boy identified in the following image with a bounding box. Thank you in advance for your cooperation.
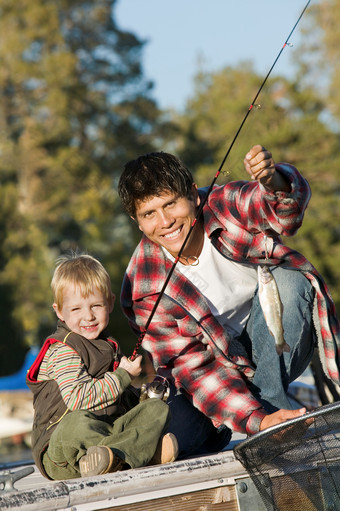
[129,0,312,361]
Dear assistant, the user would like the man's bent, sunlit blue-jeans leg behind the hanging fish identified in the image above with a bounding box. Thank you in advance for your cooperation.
[240,267,315,413]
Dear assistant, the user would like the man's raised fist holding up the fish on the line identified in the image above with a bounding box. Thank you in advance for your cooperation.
[243,145,291,192]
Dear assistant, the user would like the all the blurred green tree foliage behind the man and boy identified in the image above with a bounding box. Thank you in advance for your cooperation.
[0,0,340,375]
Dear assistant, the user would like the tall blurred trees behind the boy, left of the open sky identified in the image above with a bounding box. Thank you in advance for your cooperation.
[0,0,165,373]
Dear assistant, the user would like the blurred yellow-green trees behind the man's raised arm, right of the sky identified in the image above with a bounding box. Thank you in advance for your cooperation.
[171,63,340,309]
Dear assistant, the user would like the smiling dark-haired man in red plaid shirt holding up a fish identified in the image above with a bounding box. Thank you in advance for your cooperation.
[119,145,340,451]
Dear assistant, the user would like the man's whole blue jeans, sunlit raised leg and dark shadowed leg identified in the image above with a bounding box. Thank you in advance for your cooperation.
[168,267,315,457]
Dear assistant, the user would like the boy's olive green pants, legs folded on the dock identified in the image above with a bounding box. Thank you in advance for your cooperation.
[43,399,170,480]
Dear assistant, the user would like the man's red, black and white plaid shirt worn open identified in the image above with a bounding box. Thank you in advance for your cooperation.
[121,164,340,434]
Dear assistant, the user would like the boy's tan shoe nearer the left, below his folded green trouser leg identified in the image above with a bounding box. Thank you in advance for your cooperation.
[79,445,125,477]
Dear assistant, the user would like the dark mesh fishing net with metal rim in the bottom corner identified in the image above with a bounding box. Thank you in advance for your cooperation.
[234,402,340,511]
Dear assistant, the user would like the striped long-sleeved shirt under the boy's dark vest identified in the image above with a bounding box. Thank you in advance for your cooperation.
[38,343,124,410]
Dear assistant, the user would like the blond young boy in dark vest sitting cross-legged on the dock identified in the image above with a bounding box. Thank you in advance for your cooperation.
[27,255,178,479]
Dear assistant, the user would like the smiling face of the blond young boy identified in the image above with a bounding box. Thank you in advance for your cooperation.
[53,285,114,339]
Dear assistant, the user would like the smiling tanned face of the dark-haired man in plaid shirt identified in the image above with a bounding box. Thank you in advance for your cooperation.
[135,185,200,257]
